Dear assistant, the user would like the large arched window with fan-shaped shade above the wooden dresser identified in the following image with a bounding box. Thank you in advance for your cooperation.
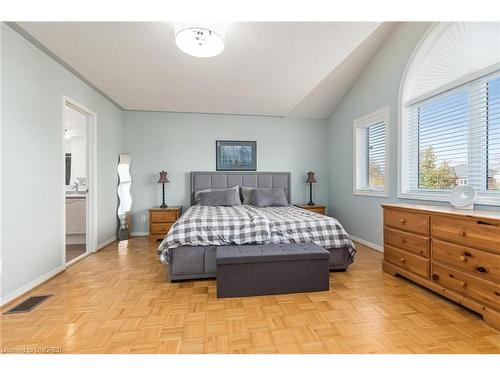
[398,22,500,205]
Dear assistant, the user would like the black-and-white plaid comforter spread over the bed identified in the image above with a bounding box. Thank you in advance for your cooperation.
[158,205,356,263]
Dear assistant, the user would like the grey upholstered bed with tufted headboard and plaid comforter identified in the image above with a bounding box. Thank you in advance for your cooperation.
[158,172,356,281]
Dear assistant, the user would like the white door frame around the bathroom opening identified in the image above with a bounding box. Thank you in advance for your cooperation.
[61,95,97,268]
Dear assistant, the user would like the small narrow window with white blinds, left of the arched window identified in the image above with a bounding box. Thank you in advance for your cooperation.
[353,107,389,197]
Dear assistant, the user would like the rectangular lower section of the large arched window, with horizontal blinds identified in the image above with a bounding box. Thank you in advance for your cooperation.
[402,71,500,204]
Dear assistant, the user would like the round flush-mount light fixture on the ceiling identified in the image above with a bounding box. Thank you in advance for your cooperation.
[175,23,225,57]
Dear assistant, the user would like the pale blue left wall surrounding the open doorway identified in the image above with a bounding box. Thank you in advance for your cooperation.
[0,23,121,301]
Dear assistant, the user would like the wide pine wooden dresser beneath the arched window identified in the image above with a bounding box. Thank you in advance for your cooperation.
[382,204,500,329]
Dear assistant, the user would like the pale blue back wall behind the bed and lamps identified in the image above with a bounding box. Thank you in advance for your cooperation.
[122,111,328,233]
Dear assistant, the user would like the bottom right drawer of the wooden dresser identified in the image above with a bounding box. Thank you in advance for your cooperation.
[432,262,500,309]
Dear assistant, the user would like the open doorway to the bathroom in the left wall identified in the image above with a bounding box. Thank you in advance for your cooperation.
[63,97,96,265]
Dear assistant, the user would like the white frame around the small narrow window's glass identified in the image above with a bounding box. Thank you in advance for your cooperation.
[352,106,390,198]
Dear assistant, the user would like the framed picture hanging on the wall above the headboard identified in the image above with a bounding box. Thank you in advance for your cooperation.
[215,141,257,171]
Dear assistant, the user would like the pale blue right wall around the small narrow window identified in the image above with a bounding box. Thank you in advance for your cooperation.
[328,22,500,246]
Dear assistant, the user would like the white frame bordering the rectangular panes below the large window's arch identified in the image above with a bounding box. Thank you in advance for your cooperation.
[398,68,500,206]
